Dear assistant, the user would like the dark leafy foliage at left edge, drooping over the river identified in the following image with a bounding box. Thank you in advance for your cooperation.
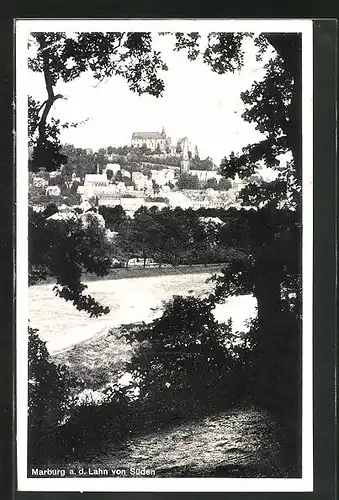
[29,210,111,316]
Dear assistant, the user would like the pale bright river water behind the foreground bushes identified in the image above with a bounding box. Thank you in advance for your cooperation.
[29,272,256,353]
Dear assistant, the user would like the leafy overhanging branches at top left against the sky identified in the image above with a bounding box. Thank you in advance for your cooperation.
[29,32,167,170]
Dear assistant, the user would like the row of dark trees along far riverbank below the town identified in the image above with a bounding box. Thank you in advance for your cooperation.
[99,206,246,267]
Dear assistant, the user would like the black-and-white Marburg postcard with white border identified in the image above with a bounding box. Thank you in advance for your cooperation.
[15,19,313,492]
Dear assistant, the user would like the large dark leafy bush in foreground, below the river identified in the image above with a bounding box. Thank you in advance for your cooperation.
[124,297,249,426]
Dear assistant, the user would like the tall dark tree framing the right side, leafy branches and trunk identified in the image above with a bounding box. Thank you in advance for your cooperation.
[176,33,302,458]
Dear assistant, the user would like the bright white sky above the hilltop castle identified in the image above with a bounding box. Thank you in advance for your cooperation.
[27,34,272,165]
